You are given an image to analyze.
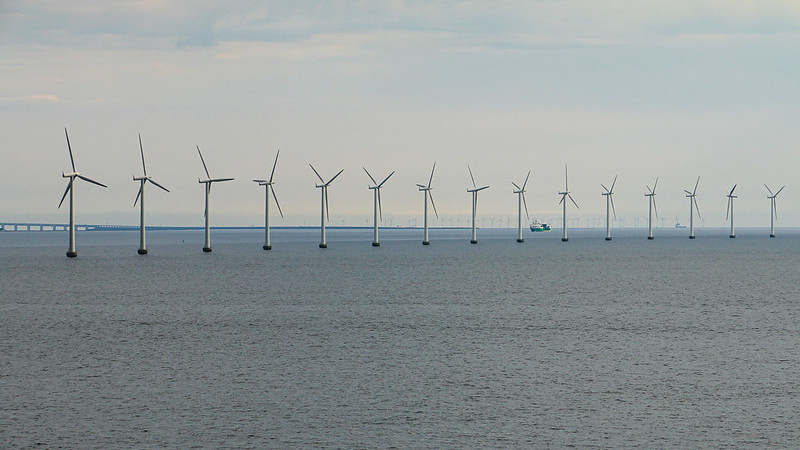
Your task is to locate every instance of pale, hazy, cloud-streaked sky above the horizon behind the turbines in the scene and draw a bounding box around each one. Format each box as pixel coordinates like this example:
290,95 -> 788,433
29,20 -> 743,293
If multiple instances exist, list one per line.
0,0 -> 800,227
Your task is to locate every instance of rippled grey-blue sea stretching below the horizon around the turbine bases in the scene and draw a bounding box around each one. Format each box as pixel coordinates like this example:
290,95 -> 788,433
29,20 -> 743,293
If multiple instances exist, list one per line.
0,228 -> 800,448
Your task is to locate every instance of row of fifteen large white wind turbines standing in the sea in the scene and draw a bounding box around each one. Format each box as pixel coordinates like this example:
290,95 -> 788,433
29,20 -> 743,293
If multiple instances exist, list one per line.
58,128 -> 786,258
